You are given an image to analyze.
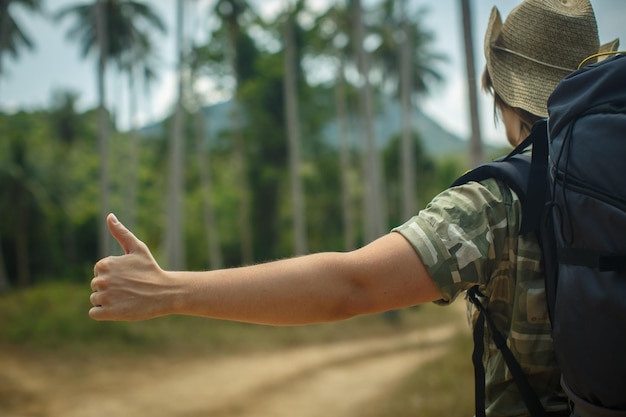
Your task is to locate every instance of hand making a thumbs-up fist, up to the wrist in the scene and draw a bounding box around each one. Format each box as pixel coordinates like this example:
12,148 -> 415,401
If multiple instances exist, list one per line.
89,214 -> 174,321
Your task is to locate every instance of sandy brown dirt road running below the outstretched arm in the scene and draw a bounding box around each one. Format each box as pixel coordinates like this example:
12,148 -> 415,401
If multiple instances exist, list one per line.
0,312 -> 461,417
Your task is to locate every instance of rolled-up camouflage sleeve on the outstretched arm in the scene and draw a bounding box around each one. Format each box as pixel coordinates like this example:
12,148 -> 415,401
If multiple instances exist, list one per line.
393,179 -> 521,304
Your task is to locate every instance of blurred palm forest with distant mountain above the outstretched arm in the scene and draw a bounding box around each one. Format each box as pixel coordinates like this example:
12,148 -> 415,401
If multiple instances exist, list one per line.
0,0 -> 510,290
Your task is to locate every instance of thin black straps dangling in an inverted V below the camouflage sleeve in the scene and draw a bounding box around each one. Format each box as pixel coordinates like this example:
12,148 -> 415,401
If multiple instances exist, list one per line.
467,285 -> 546,417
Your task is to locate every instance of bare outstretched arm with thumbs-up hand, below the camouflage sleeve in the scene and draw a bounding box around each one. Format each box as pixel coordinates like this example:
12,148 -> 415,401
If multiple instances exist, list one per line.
89,215 -> 441,325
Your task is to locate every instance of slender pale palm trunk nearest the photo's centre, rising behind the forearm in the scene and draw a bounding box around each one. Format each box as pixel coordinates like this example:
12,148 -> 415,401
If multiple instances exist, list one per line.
283,10 -> 308,255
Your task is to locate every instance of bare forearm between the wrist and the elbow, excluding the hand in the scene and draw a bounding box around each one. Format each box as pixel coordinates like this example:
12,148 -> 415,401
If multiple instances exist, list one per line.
167,253 -> 374,325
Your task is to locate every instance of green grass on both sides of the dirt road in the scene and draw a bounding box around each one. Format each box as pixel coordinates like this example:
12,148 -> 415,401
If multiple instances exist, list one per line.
0,283 -> 474,417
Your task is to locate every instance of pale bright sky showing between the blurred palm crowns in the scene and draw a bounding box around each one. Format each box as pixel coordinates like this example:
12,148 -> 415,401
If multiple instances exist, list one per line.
0,0 -> 626,144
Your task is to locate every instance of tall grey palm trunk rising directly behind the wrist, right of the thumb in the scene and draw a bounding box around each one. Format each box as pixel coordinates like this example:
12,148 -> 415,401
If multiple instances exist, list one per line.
165,0 -> 185,270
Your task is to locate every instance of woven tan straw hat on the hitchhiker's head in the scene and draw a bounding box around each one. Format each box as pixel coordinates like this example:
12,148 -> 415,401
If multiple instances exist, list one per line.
485,0 -> 619,117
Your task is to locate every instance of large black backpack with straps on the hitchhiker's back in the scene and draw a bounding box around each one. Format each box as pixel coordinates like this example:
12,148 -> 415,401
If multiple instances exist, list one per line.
453,55 -> 626,417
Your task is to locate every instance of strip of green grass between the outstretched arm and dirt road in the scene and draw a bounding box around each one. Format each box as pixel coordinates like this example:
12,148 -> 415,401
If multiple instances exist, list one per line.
0,283 -> 458,354
